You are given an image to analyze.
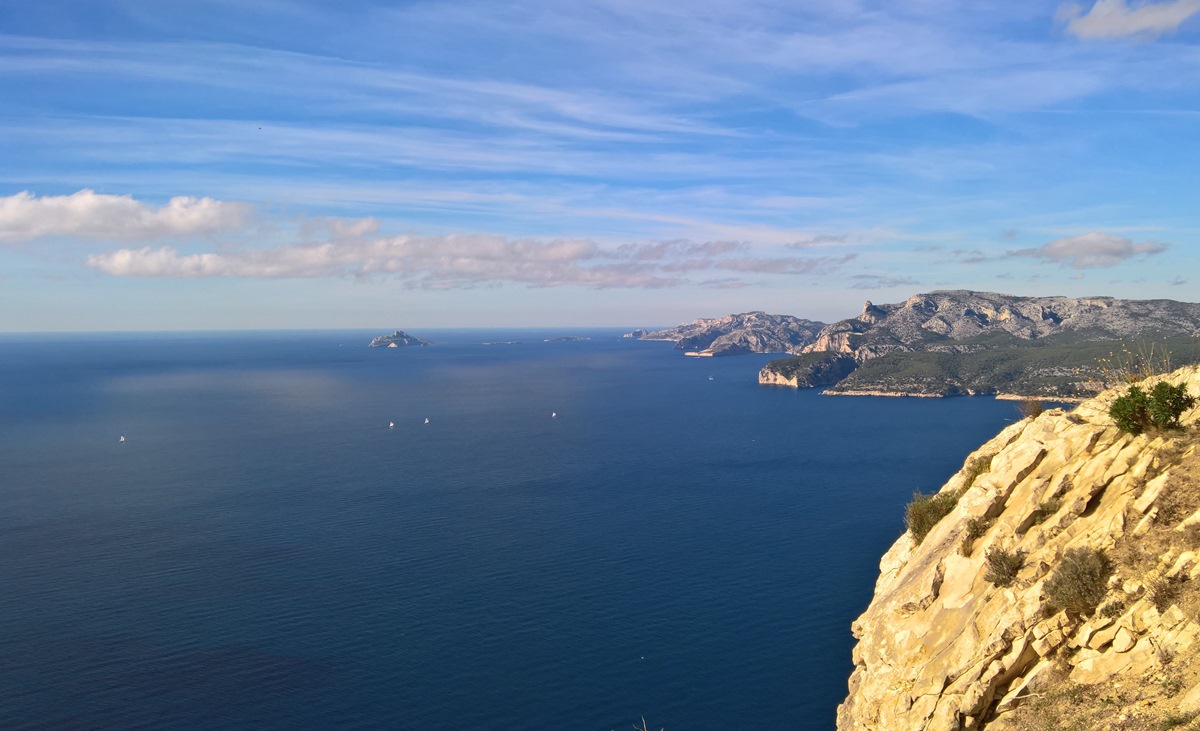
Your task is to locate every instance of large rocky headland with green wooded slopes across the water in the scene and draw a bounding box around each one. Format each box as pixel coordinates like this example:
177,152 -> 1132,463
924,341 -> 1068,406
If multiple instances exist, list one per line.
758,290 -> 1200,400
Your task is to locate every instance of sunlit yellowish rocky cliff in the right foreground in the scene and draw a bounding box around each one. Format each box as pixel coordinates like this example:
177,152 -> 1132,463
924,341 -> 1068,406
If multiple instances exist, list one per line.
838,367 -> 1200,731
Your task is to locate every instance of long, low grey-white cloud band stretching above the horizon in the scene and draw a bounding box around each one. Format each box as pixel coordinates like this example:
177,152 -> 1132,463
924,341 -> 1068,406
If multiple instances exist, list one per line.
86,234 -> 854,289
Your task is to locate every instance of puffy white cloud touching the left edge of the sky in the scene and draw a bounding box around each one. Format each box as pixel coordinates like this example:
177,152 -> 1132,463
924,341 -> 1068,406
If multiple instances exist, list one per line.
0,190 -> 251,242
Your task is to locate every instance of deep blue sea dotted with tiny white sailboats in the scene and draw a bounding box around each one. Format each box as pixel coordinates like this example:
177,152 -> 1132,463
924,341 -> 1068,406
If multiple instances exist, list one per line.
0,330 -> 1016,731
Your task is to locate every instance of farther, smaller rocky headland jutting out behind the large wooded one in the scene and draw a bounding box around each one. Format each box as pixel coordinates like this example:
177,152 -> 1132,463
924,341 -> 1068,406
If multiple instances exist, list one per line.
641,312 -> 824,355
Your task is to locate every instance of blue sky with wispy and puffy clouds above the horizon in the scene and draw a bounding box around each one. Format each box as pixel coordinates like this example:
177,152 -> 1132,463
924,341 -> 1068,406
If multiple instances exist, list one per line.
0,0 -> 1200,332
